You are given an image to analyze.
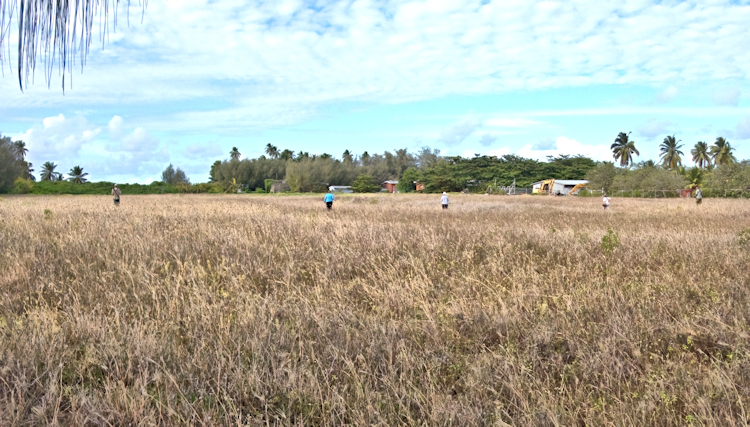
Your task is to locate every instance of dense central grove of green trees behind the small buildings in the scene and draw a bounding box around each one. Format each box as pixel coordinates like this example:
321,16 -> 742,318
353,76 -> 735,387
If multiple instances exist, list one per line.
210,144 -> 596,192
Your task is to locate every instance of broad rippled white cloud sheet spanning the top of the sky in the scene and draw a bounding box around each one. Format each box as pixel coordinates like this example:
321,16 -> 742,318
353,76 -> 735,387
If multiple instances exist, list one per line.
0,0 -> 750,130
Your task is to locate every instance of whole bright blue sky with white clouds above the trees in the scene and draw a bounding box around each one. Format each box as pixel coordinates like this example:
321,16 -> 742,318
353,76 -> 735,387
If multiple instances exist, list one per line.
0,0 -> 750,183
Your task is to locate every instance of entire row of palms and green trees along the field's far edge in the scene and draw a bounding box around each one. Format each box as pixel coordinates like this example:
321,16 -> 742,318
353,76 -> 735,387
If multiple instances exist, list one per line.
0,132 -> 750,196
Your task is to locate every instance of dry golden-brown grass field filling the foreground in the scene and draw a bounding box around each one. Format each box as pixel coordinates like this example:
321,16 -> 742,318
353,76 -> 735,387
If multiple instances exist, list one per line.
0,195 -> 750,426
